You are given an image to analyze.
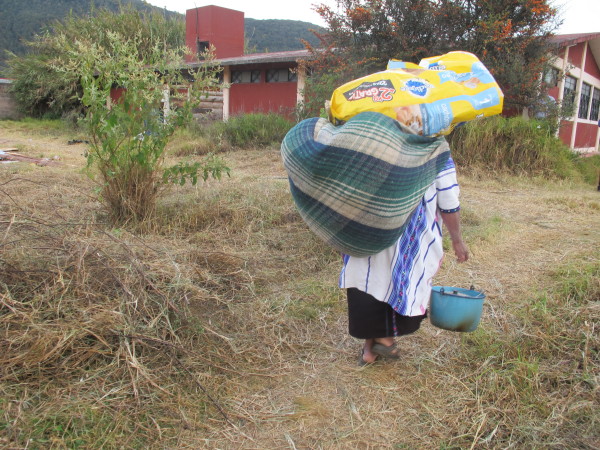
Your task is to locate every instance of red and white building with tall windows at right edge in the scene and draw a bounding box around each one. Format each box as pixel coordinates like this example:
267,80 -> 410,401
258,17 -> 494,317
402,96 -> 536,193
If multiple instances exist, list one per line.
545,33 -> 600,152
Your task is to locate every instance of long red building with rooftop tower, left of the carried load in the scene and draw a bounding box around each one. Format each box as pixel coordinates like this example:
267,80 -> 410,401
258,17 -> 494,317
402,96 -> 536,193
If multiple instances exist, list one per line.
186,6 -> 310,120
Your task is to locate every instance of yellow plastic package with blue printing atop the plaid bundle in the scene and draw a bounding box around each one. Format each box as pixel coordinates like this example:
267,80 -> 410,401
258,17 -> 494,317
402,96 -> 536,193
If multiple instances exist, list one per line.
330,52 -> 504,136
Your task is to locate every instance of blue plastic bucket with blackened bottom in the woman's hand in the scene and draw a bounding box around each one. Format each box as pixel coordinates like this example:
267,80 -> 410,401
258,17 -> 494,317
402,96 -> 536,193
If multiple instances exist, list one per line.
429,286 -> 485,332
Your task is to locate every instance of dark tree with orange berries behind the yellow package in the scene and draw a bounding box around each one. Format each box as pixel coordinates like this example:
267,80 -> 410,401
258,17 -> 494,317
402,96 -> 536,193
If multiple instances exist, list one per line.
310,0 -> 558,112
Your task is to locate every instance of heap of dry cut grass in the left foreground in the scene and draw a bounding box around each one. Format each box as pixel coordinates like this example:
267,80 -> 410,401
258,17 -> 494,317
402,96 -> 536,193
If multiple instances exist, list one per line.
0,169 -> 260,448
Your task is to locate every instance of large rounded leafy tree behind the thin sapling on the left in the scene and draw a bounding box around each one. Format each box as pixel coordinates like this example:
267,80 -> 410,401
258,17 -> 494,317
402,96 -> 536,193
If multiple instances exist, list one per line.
8,6 -> 185,117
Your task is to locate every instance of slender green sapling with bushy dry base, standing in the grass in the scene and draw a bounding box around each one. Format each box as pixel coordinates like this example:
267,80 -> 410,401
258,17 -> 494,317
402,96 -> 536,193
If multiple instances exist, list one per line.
54,31 -> 229,224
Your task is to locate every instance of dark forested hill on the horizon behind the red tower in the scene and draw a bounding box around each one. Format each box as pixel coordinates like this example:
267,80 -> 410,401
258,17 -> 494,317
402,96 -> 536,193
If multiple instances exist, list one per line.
0,0 -> 322,75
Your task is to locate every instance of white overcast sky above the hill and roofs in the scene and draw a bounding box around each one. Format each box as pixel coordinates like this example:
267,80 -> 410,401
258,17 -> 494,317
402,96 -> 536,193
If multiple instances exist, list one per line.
146,0 -> 600,34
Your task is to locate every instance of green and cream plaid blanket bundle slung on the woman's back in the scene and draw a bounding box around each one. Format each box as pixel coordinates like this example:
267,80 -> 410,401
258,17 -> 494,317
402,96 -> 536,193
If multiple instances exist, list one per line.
281,112 -> 450,256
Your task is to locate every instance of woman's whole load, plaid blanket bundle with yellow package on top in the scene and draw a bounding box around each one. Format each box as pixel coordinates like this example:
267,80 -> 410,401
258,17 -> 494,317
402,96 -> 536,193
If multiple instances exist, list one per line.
281,52 -> 503,256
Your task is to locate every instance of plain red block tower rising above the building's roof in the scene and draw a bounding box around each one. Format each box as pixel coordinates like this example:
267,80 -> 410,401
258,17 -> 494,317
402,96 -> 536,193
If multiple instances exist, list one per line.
185,5 -> 244,62
